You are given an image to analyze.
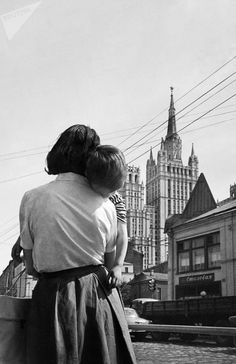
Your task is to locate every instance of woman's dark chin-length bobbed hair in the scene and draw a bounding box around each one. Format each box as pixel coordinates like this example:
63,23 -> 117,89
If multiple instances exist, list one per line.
46,124 -> 100,176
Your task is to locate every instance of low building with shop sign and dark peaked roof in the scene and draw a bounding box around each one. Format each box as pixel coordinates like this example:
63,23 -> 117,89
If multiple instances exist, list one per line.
165,174 -> 236,299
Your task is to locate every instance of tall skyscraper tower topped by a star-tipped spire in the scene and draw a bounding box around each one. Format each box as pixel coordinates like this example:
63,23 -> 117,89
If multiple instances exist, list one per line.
146,87 -> 198,264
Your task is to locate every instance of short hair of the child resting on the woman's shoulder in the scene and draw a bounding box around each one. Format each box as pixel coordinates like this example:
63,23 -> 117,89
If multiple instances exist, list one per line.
86,145 -> 126,191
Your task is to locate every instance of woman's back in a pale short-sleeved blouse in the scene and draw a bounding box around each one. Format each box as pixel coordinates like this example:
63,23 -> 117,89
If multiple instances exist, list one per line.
21,173 -> 117,272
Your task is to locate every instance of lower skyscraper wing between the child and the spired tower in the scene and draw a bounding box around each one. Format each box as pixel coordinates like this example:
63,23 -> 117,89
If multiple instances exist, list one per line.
119,166 -> 156,269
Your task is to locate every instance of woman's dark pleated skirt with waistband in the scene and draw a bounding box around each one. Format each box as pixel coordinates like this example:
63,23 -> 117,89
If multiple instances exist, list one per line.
27,266 -> 136,364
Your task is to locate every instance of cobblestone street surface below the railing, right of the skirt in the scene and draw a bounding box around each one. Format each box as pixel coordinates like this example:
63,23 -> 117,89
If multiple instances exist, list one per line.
133,340 -> 236,364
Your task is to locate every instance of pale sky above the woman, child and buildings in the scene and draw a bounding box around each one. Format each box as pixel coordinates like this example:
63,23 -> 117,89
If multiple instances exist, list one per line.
0,0 -> 236,272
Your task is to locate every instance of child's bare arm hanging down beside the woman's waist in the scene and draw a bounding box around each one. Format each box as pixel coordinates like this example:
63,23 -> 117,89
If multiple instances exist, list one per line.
105,220 -> 128,288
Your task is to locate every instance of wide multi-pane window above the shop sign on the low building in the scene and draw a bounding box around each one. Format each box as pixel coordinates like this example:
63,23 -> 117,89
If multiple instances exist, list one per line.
177,232 -> 220,273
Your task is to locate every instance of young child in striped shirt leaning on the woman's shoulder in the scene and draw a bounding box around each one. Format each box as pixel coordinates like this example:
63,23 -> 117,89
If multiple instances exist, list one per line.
86,145 -> 128,288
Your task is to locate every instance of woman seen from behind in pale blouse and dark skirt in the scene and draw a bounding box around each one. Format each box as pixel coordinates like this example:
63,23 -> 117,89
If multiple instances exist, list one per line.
20,125 -> 136,364
